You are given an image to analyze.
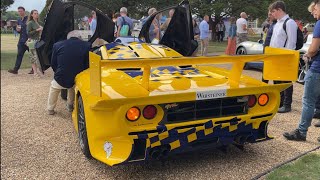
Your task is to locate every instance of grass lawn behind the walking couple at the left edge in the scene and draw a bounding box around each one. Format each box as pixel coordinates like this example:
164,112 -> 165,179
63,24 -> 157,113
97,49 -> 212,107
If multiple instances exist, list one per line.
1,34 -> 31,70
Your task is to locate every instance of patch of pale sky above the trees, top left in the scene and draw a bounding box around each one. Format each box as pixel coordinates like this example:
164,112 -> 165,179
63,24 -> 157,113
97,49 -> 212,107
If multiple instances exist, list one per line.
7,0 -> 46,12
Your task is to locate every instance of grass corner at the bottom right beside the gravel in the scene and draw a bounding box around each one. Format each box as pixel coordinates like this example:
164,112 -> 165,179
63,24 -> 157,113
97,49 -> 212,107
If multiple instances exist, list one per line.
266,153 -> 320,180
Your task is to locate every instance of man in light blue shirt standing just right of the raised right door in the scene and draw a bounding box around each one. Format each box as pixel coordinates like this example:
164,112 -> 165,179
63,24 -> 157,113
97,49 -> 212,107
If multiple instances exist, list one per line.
199,15 -> 212,56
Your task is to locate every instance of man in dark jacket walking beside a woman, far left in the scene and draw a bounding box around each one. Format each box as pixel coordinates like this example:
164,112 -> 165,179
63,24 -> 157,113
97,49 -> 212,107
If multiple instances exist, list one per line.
8,6 -> 31,74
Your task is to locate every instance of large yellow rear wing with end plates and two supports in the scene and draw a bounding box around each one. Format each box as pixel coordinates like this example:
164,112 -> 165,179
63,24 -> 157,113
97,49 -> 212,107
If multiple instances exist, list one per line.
89,47 -> 299,97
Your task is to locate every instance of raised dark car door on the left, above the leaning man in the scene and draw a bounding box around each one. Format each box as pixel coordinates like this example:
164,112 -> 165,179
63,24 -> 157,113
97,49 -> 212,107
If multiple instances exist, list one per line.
36,0 -> 115,70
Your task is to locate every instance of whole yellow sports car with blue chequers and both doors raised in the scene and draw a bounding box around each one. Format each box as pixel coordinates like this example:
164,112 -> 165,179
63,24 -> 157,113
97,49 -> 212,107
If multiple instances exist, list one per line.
37,0 -> 299,166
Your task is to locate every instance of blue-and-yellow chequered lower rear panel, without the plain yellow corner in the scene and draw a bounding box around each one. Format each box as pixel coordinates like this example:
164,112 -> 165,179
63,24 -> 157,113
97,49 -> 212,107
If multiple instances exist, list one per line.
127,118 -> 271,162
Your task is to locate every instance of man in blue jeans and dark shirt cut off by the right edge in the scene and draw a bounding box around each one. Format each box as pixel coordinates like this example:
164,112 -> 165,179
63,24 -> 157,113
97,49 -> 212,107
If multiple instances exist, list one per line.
283,0 -> 320,142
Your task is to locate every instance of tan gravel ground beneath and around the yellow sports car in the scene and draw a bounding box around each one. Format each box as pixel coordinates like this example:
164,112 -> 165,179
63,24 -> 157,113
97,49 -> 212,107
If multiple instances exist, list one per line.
1,69 -> 320,180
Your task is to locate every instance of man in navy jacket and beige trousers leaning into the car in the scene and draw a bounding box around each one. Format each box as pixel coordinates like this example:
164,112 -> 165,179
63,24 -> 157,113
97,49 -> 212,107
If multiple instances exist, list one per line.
47,31 -> 91,115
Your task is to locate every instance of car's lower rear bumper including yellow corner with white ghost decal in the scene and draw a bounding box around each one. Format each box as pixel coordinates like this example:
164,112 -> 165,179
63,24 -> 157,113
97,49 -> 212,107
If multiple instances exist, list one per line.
90,113 -> 274,166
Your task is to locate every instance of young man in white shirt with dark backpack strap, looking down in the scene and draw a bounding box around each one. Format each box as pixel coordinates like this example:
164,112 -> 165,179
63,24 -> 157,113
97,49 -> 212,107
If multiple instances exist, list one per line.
269,1 -> 298,113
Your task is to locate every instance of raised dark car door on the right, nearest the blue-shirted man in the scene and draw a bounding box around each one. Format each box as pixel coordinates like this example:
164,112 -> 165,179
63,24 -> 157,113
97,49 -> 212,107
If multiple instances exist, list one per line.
139,1 -> 198,56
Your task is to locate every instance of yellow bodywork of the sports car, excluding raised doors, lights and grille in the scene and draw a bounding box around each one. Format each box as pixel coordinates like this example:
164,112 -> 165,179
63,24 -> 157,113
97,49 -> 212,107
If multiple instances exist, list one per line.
72,43 -> 299,166
